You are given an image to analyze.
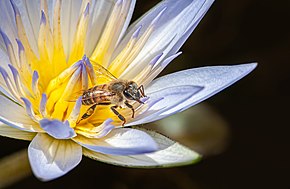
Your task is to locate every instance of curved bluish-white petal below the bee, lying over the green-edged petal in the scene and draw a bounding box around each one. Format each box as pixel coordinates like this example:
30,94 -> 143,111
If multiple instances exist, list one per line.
73,128 -> 157,155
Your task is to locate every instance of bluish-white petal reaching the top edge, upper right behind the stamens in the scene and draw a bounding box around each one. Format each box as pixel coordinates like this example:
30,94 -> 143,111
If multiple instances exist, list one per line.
114,0 -> 214,77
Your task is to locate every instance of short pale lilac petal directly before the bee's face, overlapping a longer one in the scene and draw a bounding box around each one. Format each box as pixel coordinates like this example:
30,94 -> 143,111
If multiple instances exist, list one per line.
126,85 -> 203,126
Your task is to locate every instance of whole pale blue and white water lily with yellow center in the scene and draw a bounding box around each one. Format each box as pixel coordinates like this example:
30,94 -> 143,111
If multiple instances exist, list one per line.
0,0 -> 256,181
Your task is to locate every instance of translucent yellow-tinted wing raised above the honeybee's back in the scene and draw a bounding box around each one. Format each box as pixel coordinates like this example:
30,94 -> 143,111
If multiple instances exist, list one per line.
93,63 -> 117,84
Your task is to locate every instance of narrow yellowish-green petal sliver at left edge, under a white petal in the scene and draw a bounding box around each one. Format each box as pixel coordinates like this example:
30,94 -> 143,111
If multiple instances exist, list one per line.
0,123 -> 36,141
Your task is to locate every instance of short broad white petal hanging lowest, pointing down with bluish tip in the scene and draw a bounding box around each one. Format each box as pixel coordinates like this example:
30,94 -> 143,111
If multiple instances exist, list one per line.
28,133 -> 82,181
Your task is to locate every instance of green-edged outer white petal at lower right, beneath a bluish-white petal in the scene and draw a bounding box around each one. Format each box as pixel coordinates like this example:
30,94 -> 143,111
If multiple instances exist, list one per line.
83,128 -> 201,168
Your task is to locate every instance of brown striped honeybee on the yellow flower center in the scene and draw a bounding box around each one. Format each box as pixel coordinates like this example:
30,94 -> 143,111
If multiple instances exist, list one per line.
79,63 -> 146,126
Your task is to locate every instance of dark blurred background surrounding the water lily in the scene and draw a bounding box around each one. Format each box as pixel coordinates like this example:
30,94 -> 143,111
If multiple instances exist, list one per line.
0,0 -> 290,189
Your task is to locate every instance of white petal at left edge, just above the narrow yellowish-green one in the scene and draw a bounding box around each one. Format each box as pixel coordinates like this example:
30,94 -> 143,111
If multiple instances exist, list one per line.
0,95 -> 43,132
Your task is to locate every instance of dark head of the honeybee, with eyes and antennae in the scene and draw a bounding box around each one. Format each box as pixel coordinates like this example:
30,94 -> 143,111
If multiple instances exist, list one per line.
123,81 -> 144,103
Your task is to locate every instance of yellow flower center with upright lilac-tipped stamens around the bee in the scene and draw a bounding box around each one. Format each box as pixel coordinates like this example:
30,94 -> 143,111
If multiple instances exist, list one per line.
2,1 -> 152,137
